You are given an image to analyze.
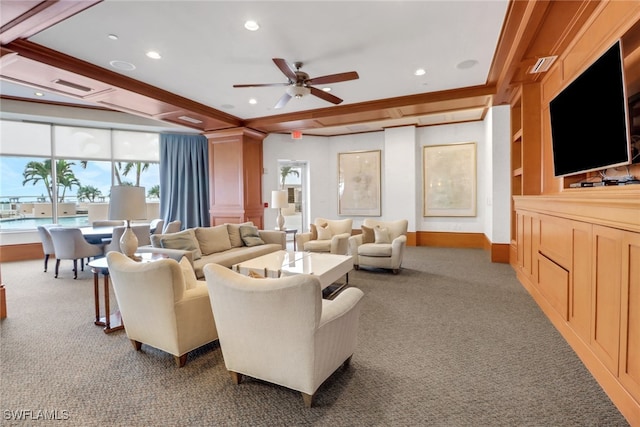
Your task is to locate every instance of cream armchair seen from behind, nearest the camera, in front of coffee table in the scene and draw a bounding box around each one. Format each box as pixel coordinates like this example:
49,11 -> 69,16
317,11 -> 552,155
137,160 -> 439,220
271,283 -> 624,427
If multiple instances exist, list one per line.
204,264 -> 363,407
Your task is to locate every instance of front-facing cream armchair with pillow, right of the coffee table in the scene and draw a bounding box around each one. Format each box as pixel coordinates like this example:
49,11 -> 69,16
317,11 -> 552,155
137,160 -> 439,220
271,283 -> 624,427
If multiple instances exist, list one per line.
349,219 -> 408,274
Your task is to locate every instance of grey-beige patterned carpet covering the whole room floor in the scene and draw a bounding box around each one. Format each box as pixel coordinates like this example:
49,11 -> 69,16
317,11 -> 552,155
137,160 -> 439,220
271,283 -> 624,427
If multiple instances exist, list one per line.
0,247 -> 628,426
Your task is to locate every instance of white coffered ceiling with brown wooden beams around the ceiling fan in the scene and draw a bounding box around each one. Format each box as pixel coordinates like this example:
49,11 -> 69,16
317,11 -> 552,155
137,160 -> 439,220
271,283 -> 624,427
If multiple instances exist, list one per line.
0,0 -> 597,135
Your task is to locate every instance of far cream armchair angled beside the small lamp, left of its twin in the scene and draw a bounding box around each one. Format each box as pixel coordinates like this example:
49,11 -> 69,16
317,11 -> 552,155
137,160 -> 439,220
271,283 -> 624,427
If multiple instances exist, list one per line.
296,218 -> 353,255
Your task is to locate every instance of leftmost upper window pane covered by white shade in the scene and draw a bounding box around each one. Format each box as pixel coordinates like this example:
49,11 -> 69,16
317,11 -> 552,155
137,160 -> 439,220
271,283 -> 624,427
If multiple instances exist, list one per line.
0,120 -> 51,156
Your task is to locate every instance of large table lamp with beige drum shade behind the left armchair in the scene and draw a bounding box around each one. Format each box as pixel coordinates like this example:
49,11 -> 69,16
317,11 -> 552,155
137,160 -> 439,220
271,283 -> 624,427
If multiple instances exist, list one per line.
109,185 -> 147,258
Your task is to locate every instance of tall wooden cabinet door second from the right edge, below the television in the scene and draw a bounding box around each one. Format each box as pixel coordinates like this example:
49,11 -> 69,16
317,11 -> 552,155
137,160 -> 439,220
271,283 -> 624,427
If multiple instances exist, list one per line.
591,225 -> 624,376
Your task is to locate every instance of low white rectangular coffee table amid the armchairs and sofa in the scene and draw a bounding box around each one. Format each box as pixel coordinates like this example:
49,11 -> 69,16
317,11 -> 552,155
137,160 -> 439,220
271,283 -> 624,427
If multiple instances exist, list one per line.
232,251 -> 353,294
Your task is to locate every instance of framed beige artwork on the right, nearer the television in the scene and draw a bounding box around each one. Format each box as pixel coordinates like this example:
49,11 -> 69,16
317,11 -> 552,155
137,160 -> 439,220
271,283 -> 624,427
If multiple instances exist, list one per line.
422,142 -> 476,216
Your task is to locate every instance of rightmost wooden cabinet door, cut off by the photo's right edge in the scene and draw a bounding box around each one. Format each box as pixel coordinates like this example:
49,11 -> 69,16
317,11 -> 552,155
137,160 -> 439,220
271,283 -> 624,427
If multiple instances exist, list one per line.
620,232 -> 640,402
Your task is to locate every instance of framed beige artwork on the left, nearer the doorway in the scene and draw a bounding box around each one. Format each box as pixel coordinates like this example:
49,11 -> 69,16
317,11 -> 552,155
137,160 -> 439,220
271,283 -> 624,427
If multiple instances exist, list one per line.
338,150 -> 381,216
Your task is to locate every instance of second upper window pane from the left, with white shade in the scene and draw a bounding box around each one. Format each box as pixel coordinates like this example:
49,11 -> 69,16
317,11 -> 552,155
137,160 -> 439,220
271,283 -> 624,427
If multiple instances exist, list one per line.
53,126 -> 111,159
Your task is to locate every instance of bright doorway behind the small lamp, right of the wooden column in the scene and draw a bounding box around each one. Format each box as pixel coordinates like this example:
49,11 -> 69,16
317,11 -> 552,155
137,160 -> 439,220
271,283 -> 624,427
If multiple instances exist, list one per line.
278,160 -> 309,237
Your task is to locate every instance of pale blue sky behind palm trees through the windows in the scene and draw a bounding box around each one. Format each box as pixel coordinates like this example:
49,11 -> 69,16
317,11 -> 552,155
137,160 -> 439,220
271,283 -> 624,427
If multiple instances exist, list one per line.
0,156 -> 160,201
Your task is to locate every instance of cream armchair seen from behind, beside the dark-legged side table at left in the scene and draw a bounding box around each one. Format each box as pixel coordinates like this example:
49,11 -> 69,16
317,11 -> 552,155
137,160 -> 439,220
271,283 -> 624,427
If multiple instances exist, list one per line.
107,252 -> 218,367
